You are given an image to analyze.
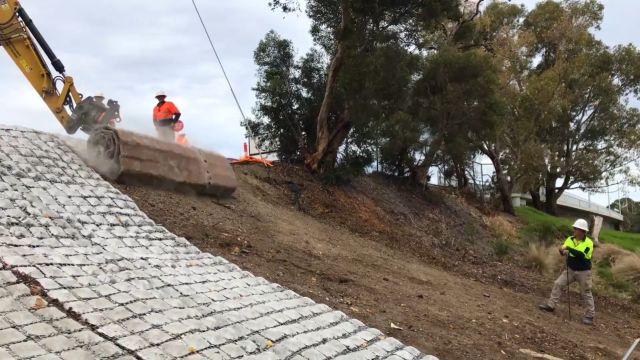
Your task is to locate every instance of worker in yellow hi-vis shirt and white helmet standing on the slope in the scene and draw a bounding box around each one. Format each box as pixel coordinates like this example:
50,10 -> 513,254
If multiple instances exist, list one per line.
539,219 -> 596,325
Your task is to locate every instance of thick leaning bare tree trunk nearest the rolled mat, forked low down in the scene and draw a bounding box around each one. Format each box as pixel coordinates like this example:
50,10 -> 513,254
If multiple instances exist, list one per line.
305,0 -> 351,173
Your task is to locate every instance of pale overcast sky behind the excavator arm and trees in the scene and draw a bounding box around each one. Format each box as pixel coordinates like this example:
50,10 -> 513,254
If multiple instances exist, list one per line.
0,0 -> 640,203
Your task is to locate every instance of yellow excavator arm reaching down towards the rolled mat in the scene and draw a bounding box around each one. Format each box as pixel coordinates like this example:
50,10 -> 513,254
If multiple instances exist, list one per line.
0,0 -> 120,134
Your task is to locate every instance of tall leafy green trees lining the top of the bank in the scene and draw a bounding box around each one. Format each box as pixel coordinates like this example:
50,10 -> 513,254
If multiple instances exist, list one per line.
258,0 -> 640,211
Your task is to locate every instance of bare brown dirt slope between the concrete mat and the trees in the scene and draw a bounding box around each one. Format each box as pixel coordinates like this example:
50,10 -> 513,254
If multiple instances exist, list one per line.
116,167 -> 640,359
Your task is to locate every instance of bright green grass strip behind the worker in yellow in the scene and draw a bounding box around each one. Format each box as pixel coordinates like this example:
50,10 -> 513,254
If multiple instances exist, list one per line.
516,206 -> 640,251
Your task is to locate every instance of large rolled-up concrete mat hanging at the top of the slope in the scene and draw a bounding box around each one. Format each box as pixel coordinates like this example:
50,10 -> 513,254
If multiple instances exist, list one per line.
86,127 -> 237,197
